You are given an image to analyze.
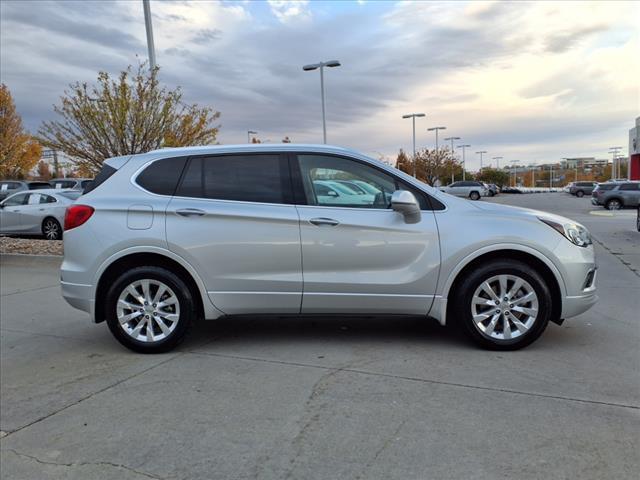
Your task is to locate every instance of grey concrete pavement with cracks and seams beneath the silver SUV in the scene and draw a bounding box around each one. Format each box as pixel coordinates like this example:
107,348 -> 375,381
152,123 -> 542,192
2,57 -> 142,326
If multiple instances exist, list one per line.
0,194 -> 640,480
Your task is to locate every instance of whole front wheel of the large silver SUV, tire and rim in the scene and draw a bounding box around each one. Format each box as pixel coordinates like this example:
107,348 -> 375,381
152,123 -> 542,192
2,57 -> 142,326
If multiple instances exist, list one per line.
451,260 -> 551,350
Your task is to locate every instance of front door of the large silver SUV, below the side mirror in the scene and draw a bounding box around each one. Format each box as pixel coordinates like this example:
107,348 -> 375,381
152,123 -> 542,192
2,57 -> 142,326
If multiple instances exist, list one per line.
297,154 -> 440,315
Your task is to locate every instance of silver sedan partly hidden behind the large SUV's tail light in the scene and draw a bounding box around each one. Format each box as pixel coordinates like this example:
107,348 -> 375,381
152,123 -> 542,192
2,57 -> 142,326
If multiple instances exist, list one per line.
0,188 -> 81,240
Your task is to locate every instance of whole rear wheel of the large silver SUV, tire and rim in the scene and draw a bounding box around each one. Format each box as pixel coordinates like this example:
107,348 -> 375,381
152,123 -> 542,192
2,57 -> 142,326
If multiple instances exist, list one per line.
106,266 -> 196,353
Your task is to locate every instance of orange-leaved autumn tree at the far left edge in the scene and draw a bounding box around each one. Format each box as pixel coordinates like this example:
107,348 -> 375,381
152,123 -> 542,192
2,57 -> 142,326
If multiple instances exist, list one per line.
0,84 -> 42,178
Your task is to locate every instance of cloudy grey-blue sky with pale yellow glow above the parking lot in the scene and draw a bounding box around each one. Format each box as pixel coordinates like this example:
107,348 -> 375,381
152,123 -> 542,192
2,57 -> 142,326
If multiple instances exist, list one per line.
0,0 -> 640,169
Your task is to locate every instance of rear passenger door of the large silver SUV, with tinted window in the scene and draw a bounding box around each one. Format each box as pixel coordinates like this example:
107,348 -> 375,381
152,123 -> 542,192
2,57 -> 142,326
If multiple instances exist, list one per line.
166,153 -> 302,314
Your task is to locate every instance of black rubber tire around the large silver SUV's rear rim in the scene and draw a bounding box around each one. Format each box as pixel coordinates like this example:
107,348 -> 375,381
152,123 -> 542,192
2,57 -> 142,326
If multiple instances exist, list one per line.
105,266 -> 197,353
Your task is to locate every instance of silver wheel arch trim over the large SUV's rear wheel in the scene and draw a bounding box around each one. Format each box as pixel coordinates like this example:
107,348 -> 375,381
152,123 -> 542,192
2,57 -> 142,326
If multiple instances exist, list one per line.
93,250 -> 222,323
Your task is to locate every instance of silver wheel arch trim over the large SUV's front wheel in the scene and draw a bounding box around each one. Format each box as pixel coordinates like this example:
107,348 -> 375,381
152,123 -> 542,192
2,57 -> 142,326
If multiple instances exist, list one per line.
432,245 -> 566,325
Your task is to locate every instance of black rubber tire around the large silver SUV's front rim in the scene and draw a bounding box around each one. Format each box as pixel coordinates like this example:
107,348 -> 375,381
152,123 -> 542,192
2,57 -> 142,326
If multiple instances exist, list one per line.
450,260 -> 552,350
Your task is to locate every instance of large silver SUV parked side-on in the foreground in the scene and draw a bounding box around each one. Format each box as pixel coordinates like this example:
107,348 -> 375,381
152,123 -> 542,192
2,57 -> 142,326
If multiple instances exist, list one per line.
61,144 -> 597,352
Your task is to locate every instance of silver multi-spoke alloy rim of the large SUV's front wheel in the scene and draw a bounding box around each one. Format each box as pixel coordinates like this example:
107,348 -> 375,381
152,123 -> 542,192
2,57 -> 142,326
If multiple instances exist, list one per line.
471,274 -> 538,341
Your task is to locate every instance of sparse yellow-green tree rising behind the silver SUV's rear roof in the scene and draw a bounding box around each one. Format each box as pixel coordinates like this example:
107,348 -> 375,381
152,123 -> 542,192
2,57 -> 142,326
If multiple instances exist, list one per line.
38,64 -> 220,173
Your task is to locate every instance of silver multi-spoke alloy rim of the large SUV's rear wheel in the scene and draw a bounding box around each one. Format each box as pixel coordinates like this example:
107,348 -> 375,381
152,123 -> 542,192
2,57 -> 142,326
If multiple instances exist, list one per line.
116,279 -> 180,343
